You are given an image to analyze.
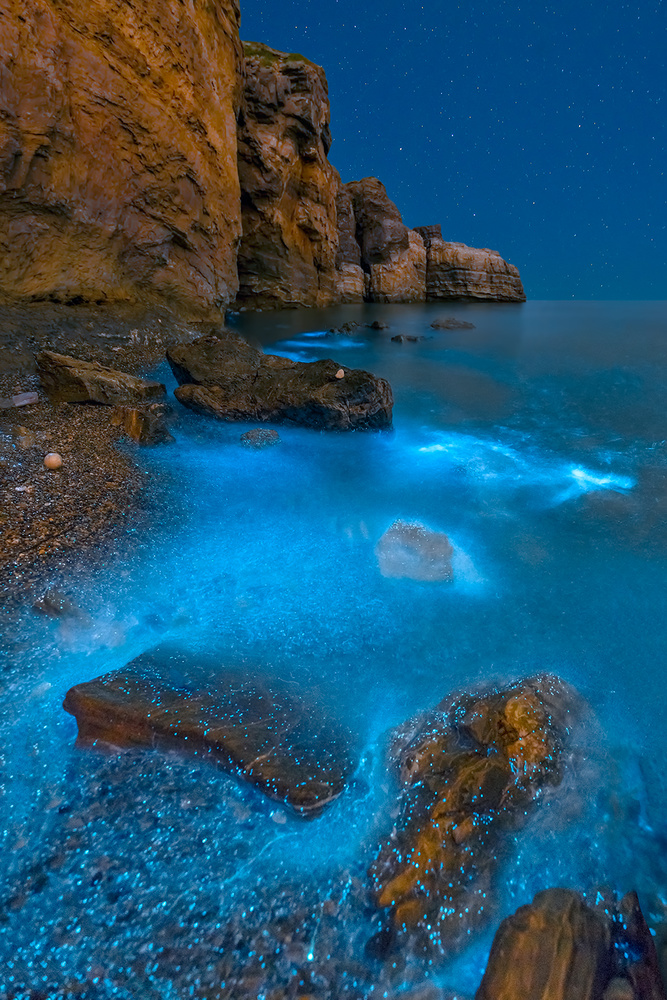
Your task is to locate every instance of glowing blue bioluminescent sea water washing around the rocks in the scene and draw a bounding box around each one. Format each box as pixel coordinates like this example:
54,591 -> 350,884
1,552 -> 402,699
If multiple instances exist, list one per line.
0,302 -> 667,1000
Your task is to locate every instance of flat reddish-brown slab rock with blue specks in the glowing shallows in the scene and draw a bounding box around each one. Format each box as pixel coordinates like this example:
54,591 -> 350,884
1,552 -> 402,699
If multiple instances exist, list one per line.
64,647 -> 356,815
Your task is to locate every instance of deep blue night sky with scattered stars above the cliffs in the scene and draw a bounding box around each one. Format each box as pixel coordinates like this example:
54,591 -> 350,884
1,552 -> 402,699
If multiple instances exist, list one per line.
241,0 -> 667,299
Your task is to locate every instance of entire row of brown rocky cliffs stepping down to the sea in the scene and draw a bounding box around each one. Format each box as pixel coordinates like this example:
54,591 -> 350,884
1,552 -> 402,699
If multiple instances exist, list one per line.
0,0 -> 524,311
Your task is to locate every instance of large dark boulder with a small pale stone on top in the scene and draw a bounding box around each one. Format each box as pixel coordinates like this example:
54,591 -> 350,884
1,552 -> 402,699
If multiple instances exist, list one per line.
167,334 -> 393,430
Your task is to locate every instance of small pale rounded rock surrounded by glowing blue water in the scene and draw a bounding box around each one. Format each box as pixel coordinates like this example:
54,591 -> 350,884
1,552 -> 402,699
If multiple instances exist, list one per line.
375,521 -> 454,583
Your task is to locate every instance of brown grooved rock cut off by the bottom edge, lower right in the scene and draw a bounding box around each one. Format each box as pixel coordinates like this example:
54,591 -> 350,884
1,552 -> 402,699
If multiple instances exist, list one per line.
476,889 -> 611,1000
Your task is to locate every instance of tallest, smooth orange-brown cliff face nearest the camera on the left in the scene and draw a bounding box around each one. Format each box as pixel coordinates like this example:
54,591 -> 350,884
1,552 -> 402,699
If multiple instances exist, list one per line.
0,0 -> 242,308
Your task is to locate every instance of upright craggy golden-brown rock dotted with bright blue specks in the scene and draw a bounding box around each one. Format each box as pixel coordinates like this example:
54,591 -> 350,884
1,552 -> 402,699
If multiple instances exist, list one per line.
370,675 -> 579,952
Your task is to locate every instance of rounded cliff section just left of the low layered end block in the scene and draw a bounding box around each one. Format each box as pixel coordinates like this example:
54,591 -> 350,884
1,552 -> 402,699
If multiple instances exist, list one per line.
346,177 -> 426,302
